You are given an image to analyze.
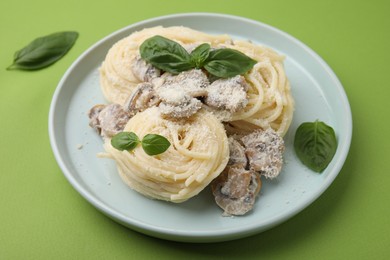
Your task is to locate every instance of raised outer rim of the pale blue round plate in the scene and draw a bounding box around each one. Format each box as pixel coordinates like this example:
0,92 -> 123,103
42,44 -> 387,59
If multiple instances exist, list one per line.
48,12 -> 352,242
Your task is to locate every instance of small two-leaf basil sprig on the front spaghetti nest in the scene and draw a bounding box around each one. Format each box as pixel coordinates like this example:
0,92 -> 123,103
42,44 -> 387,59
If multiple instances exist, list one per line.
111,132 -> 171,155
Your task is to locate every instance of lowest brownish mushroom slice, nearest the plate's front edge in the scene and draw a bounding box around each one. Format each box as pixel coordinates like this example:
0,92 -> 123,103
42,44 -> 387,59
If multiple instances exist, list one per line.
211,166 -> 261,216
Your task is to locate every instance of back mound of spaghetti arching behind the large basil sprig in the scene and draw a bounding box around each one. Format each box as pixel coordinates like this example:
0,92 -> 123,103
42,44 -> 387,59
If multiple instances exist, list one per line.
100,26 -> 294,136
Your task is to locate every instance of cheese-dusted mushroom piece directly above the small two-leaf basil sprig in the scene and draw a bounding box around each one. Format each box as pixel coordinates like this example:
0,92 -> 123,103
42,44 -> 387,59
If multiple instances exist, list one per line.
97,104 -> 131,137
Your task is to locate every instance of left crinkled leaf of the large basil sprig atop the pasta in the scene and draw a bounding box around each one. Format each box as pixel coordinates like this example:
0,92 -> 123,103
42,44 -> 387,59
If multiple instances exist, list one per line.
140,35 -> 193,74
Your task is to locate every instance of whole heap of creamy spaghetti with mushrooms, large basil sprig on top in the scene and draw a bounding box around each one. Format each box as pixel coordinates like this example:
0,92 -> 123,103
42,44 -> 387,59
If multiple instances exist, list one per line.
89,26 -> 294,215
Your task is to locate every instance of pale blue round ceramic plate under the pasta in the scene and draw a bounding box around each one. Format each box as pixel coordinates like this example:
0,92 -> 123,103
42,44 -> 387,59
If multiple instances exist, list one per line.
49,13 -> 352,242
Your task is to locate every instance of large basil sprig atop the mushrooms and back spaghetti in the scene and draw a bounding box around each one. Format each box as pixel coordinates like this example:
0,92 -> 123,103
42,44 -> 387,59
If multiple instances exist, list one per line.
140,35 -> 257,78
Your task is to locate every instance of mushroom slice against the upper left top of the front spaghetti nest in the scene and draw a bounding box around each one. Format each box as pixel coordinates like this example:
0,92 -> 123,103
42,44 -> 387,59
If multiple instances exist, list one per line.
123,82 -> 160,115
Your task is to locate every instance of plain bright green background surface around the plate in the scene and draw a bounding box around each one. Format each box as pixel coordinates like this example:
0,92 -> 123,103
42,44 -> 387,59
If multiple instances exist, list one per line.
0,0 -> 390,259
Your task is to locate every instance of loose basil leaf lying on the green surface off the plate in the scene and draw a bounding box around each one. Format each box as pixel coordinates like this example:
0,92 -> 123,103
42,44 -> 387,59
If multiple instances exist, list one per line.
7,32 -> 78,70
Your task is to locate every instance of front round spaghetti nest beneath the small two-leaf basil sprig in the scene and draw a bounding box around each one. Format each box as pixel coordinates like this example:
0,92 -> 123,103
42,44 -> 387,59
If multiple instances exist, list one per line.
104,107 -> 229,202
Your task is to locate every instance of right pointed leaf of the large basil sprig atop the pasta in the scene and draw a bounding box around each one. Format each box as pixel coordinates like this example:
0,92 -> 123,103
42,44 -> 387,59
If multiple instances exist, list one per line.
204,48 -> 257,78
